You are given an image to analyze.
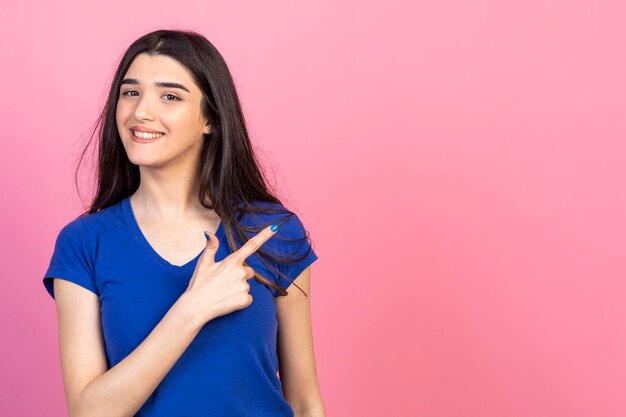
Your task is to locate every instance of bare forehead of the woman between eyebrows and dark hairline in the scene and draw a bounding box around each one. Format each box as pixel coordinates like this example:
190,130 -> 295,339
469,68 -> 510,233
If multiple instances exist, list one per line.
124,54 -> 199,92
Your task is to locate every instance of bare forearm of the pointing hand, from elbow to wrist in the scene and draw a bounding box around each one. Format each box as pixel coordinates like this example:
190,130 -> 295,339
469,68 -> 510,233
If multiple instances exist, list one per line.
70,294 -> 202,417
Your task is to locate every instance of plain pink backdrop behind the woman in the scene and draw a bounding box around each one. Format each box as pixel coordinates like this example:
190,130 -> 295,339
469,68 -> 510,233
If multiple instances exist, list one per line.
0,0 -> 626,417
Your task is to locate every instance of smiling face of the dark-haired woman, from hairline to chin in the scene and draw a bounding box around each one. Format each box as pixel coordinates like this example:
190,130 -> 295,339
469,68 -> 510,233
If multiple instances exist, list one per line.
115,54 -> 210,168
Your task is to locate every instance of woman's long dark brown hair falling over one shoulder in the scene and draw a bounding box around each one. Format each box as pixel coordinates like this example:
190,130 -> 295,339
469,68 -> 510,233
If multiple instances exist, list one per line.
75,30 -> 311,296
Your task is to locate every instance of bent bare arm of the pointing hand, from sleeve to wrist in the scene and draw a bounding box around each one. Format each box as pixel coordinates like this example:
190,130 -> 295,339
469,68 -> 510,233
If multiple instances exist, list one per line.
54,279 -> 202,417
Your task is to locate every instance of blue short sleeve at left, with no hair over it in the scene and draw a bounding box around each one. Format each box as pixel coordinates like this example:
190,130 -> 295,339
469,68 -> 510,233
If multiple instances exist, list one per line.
43,218 -> 100,298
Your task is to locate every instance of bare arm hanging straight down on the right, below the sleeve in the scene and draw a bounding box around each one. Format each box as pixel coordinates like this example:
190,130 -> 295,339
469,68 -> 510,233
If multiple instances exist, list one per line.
276,267 -> 326,417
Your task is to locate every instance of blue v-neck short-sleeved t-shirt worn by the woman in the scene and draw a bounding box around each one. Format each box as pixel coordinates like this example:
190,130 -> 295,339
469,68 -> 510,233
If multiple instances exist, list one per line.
43,197 -> 317,417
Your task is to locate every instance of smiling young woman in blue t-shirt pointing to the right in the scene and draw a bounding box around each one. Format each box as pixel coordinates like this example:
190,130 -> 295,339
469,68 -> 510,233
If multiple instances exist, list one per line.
43,30 -> 324,417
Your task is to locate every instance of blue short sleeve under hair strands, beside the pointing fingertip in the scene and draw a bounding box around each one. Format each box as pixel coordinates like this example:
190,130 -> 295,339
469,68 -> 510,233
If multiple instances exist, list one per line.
274,214 -> 318,290
